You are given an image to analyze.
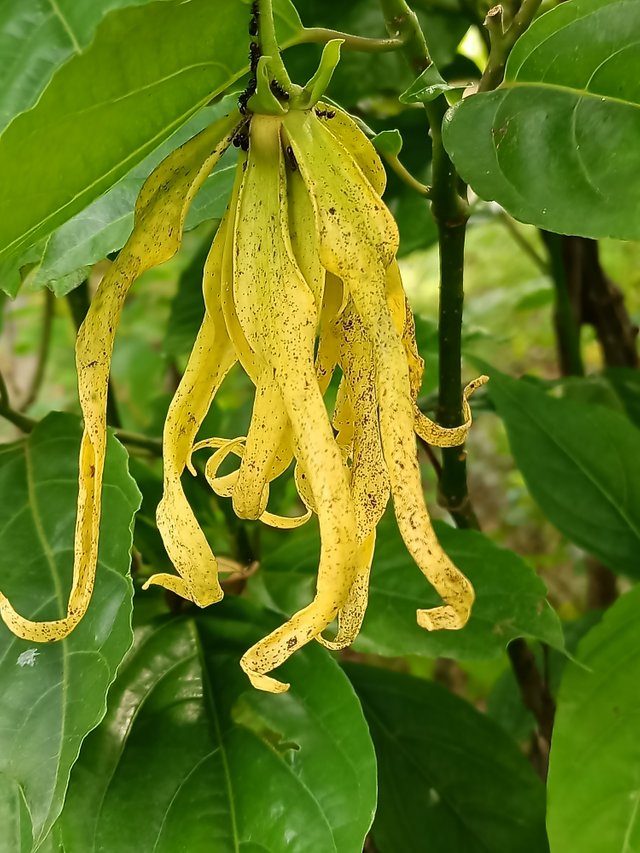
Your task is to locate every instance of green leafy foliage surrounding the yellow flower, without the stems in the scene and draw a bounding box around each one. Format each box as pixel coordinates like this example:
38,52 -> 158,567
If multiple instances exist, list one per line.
0,0 -> 640,853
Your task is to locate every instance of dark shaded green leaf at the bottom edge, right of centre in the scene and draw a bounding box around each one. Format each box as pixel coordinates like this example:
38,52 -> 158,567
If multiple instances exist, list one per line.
345,664 -> 552,853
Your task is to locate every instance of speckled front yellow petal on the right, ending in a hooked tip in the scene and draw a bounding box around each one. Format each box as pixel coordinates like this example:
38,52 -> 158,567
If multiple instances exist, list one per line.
284,112 -> 474,630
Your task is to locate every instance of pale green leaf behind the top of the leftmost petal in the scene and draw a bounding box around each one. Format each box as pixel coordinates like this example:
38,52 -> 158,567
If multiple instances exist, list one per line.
27,103 -> 237,296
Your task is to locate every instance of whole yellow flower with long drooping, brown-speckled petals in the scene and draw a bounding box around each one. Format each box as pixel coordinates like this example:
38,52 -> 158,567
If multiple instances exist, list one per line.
0,71 -> 485,692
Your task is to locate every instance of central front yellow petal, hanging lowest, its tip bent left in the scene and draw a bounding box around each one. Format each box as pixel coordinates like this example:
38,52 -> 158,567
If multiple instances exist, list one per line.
234,115 -> 356,692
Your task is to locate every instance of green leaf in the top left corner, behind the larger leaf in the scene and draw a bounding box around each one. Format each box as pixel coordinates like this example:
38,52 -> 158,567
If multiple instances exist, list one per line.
0,0 -> 175,131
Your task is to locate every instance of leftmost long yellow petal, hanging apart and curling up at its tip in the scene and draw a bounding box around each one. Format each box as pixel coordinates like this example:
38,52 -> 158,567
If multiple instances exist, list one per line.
0,113 -> 240,642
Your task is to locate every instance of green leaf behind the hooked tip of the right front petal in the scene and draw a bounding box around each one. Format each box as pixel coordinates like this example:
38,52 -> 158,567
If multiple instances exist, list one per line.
252,517 -> 563,660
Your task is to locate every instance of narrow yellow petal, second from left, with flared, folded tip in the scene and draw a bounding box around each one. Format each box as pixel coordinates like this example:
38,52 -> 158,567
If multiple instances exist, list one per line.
148,213 -> 236,607
